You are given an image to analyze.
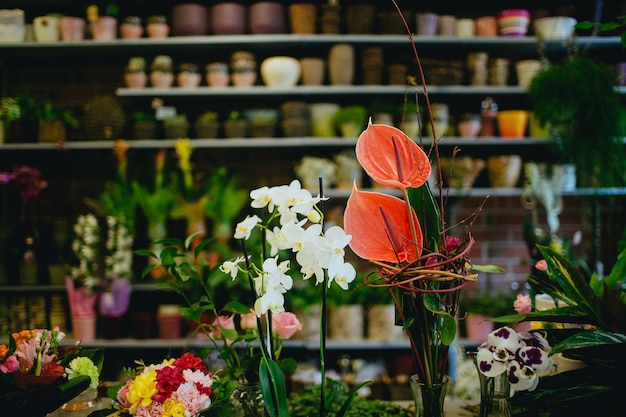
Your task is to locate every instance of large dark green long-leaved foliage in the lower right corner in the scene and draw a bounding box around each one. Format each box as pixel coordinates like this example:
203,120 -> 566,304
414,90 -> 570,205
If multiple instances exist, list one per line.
494,245 -> 626,416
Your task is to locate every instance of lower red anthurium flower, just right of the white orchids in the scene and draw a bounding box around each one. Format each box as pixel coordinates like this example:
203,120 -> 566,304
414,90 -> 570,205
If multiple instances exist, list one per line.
344,186 -> 423,263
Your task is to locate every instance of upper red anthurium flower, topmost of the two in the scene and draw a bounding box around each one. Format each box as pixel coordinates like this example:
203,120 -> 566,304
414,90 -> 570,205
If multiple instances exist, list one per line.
356,119 -> 431,189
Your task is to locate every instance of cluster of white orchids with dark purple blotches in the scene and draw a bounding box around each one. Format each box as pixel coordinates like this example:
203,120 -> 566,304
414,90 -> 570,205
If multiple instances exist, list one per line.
476,326 -> 552,391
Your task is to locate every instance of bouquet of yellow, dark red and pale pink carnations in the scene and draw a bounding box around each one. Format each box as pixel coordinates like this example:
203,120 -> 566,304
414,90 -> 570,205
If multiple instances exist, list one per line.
115,353 -> 216,417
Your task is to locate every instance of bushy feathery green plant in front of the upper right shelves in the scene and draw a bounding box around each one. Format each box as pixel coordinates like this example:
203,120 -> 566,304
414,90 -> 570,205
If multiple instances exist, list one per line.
528,56 -> 626,187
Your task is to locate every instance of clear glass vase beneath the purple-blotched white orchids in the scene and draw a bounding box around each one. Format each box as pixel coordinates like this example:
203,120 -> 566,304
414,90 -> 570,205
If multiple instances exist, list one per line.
474,357 -> 511,417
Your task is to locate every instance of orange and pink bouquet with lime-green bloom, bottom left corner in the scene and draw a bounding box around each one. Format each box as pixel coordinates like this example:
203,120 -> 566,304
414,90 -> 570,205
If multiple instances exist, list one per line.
0,328 -> 104,417
